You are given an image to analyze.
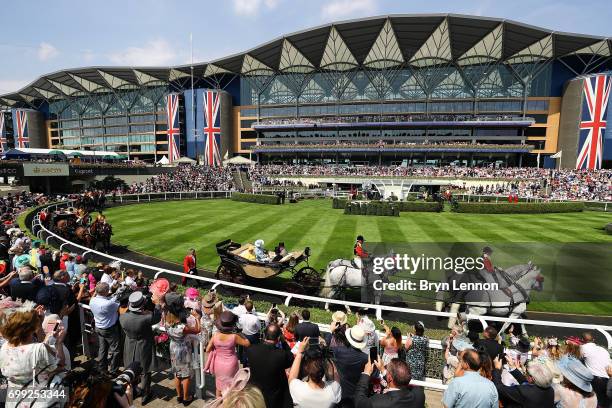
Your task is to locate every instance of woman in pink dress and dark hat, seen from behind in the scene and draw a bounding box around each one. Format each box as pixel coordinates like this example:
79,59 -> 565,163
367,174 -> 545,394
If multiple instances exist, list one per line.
205,310 -> 251,398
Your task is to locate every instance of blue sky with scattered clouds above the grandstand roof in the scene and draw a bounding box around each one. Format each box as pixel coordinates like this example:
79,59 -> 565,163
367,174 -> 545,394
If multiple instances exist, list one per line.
0,0 -> 612,94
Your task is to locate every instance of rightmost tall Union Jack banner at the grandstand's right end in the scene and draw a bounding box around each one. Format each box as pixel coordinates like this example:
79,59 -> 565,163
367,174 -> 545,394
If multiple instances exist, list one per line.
576,74 -> 612,169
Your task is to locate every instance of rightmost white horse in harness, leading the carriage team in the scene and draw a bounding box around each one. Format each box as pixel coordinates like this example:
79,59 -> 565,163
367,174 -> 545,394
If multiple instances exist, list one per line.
464,263 -> 544,334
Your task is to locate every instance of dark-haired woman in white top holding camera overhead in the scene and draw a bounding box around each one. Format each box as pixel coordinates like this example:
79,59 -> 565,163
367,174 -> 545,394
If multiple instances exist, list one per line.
288,337 -> 342,408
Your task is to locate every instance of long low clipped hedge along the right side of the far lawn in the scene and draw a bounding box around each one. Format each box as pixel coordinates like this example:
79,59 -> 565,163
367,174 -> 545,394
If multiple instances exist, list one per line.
453,202 -> 584,214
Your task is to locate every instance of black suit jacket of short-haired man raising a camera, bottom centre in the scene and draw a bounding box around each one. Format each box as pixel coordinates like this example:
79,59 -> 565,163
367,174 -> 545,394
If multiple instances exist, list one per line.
355,374 -> 425,408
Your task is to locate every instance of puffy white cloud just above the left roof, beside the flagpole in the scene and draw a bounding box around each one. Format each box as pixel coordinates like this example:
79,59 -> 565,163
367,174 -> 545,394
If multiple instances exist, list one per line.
108,39 -> 180,66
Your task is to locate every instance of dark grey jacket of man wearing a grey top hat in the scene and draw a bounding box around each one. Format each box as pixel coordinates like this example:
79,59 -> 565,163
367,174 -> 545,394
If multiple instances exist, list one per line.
119,309 -> 161,373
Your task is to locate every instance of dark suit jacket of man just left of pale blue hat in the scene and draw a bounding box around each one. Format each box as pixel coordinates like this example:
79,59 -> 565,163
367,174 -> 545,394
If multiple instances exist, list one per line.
493,370 -> 555,408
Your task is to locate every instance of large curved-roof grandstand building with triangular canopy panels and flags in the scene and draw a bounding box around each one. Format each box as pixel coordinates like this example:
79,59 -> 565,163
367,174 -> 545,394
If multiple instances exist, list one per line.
0,14 -> 612,168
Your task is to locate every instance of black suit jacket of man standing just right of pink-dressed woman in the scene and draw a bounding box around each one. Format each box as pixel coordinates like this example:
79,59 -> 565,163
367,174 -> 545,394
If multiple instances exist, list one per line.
246,343 -> 293,408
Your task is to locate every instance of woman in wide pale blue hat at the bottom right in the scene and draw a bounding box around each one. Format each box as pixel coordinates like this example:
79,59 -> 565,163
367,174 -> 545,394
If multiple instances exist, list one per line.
555,356 -> 597,408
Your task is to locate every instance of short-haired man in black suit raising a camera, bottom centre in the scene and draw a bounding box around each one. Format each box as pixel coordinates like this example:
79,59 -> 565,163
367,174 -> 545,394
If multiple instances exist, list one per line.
355,358 -> 425,408
